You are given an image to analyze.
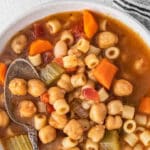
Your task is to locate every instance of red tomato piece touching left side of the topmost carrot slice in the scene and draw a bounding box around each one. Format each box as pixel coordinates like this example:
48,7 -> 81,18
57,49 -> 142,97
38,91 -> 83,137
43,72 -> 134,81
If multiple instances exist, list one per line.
71,21 -> 85,40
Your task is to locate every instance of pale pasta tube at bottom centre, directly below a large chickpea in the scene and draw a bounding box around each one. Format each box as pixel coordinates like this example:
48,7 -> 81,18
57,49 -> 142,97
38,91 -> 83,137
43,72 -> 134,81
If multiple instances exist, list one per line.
62,137 -> 78,149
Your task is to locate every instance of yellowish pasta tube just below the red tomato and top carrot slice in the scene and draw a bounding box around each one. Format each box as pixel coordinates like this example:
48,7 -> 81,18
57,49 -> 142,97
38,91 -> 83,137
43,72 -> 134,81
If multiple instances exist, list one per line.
76,38 -> 90,53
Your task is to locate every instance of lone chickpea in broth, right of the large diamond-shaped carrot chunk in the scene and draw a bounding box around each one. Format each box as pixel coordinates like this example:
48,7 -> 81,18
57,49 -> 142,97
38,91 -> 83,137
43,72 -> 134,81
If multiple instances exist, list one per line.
113,79 -> 133,96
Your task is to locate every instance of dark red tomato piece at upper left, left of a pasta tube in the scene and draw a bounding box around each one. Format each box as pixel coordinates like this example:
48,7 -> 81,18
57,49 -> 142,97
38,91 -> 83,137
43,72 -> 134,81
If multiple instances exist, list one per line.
33,23 -> 44,38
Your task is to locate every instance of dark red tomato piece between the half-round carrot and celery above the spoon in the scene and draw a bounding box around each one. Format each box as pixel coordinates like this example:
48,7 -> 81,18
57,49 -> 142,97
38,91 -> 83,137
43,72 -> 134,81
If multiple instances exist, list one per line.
42,51 -> 54,64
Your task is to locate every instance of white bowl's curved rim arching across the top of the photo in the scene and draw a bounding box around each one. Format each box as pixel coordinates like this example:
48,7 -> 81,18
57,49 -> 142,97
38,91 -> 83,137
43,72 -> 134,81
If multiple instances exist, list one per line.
0,0 -> 150,150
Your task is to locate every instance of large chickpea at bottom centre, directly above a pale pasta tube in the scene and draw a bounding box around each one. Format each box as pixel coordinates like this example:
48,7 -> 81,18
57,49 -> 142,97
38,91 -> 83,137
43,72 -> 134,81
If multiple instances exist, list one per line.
64,119 -> 83,140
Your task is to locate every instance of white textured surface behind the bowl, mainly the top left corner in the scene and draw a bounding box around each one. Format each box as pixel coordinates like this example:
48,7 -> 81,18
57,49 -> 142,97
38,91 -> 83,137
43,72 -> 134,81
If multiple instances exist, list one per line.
0,0 -> 111,33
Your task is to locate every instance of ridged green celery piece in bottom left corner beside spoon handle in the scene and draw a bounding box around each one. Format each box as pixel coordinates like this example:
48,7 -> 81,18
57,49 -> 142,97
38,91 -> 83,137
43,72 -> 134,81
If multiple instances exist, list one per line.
2,135 -> 32,150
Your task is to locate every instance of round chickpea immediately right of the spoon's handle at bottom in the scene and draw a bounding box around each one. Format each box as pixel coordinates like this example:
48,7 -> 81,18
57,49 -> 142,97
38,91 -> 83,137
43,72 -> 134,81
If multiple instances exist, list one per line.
39,125 -> 56,144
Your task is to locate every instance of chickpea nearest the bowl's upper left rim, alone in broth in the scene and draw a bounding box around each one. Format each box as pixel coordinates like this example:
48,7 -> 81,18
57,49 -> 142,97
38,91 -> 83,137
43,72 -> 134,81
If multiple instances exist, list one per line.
11,34 -> 27,54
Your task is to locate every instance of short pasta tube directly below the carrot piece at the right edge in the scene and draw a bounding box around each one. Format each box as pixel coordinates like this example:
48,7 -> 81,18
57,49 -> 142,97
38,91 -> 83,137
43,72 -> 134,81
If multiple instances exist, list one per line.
134,114 -> 147,126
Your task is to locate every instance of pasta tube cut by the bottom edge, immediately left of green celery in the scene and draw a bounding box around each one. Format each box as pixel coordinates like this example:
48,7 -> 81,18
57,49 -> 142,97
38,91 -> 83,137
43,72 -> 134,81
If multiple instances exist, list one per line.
85,139 -> 98,150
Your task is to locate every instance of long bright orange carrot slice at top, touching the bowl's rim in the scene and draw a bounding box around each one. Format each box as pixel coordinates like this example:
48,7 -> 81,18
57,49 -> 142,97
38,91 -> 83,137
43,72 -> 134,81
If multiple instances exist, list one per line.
83,10 -> 98,39
